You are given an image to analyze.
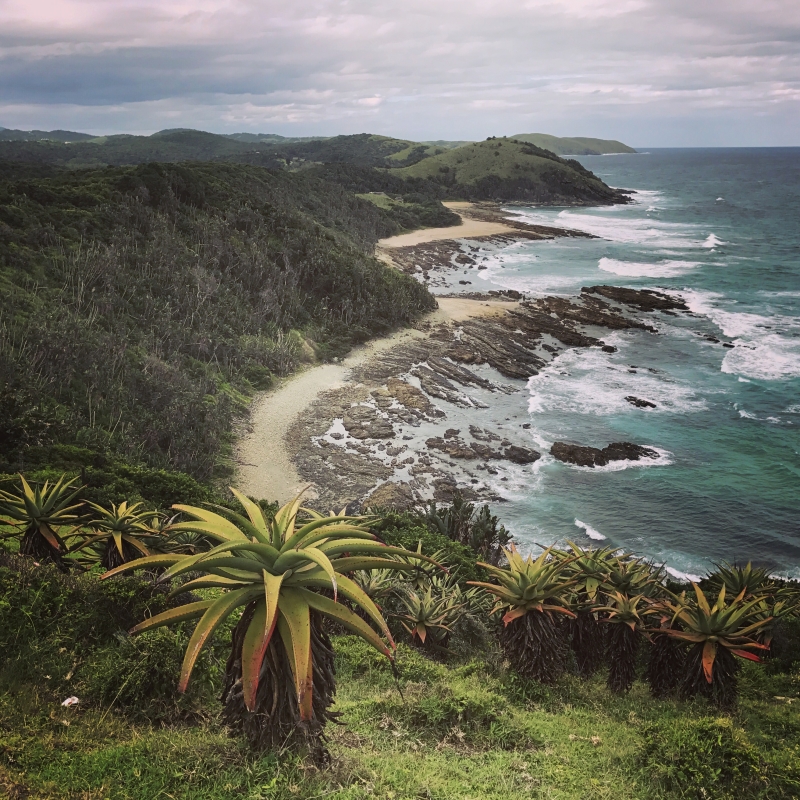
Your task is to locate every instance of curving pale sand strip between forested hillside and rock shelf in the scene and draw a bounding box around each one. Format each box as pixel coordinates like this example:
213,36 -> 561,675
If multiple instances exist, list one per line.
235,297 -> 514,503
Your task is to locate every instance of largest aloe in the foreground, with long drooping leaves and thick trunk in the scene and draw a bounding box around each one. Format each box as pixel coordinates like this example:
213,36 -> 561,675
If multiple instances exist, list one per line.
103,490 -> 432,757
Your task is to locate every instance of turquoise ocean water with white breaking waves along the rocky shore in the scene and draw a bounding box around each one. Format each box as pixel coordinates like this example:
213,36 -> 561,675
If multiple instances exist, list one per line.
454,148 -> 800,577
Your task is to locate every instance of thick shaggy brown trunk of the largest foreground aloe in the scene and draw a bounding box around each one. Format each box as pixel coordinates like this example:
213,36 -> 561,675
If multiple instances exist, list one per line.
221,603 -> 339,764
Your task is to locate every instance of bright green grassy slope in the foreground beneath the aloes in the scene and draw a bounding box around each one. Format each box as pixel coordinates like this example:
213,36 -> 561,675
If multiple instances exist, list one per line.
0,637 -> 800,800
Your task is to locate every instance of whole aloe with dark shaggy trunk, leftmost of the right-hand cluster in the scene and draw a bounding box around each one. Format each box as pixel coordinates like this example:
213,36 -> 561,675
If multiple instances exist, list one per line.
468,544 -> 575,683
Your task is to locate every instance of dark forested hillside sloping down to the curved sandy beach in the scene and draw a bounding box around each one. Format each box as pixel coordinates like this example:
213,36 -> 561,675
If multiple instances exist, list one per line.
0,163 -> 435,488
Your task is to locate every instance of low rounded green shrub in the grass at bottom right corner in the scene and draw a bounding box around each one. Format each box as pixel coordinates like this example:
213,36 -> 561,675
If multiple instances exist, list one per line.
637,716 -> 768,800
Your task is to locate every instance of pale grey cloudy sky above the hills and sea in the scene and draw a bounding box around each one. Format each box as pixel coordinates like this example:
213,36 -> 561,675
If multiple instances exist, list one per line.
0,0 -> 800,146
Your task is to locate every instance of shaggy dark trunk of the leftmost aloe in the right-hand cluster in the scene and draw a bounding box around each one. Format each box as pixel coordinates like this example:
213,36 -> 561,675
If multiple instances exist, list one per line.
500,611 -> 567,683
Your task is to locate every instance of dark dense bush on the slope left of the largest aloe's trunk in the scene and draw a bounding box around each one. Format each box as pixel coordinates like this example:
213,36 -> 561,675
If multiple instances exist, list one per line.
0,555 -> 223,720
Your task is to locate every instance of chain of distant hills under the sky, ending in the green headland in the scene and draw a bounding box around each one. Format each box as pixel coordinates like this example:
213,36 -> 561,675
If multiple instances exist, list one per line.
0,128 -> 624,203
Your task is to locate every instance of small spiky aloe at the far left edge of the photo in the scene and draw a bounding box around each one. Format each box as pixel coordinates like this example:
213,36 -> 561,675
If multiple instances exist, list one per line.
0,475 -> 83,571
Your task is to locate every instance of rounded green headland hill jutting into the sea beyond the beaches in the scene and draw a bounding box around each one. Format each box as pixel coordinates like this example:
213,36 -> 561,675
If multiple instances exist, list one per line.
393,138 -> 626,204
